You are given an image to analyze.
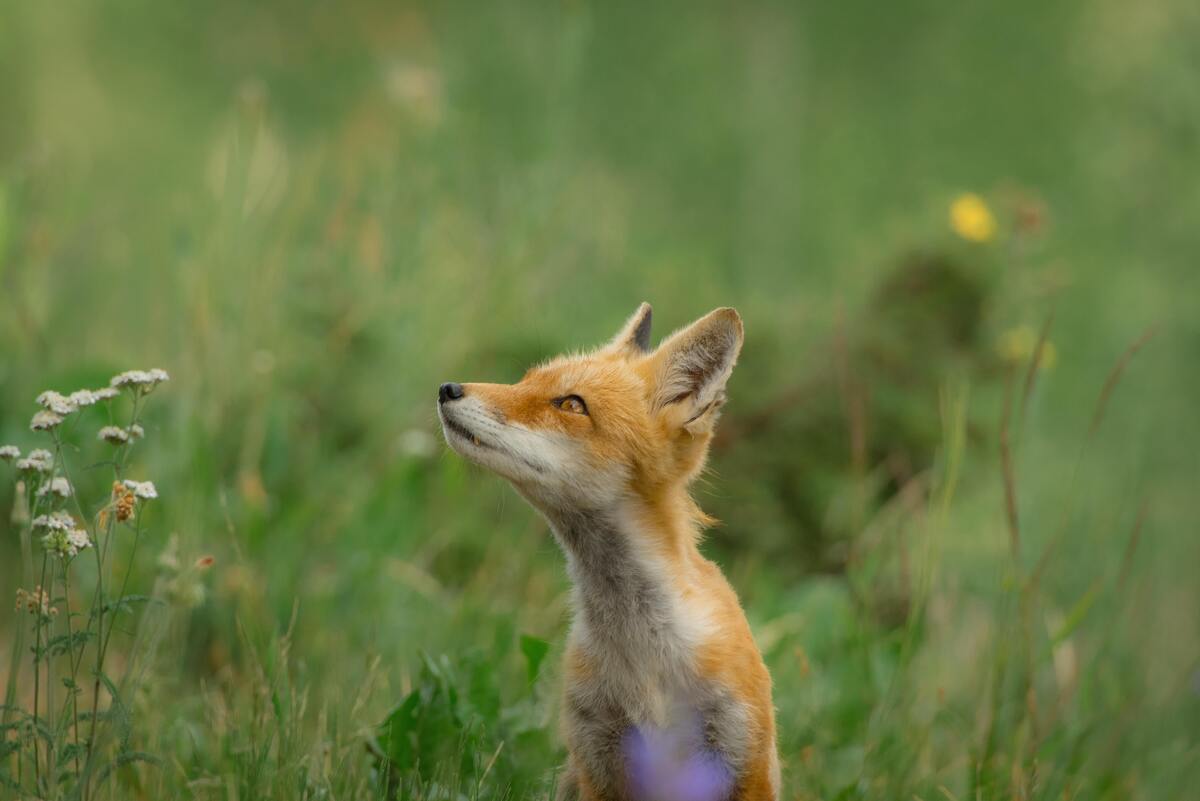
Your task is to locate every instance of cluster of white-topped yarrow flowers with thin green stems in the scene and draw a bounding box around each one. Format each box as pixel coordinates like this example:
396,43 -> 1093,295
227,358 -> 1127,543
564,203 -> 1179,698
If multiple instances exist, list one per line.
0,368 -> 169,799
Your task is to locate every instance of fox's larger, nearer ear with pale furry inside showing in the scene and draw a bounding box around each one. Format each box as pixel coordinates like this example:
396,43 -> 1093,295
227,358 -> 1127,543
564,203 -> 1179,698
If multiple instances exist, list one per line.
654,308 -> 743,429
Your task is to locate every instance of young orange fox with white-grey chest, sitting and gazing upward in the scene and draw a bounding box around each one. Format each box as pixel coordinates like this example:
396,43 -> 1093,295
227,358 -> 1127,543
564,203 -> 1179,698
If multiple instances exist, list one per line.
438,303 -> 779,801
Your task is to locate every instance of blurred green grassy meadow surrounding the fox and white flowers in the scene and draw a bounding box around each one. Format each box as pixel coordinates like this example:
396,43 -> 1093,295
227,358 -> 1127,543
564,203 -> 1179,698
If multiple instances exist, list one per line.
0,0 -> 1200,801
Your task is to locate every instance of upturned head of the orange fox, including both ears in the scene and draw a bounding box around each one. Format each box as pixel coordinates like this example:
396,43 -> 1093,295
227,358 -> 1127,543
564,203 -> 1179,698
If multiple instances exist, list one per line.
438,303 -> 743,518
